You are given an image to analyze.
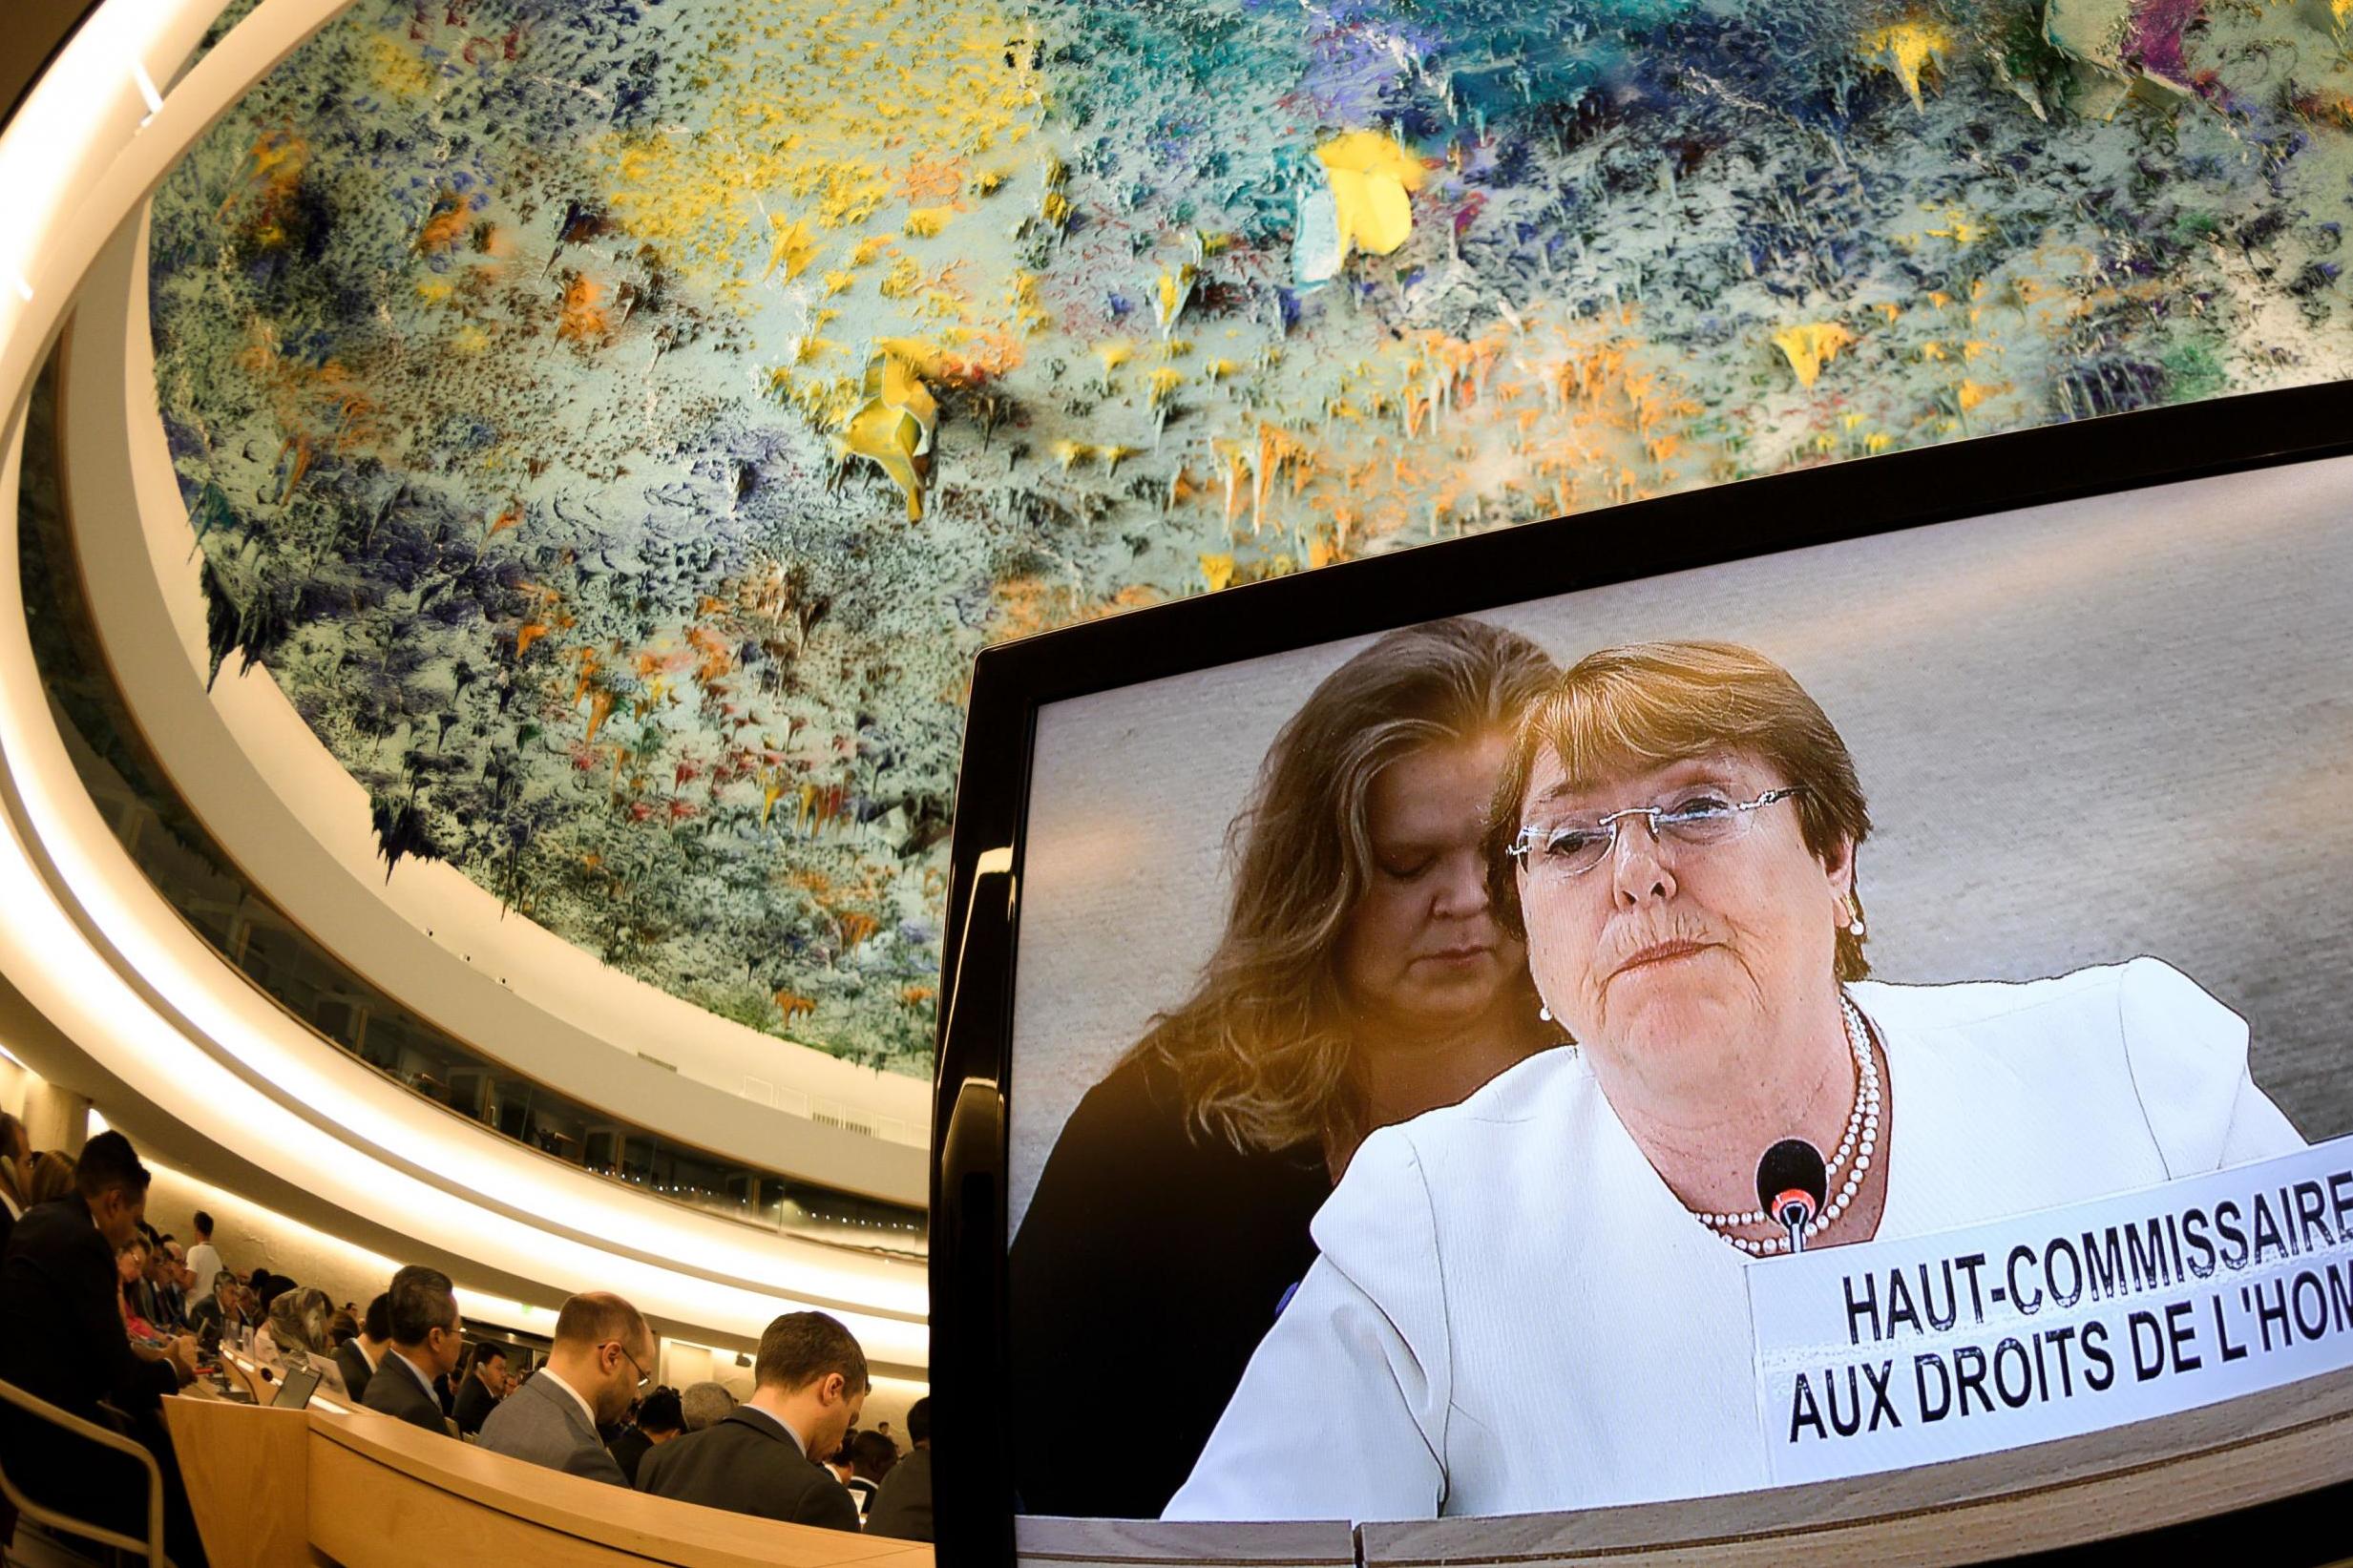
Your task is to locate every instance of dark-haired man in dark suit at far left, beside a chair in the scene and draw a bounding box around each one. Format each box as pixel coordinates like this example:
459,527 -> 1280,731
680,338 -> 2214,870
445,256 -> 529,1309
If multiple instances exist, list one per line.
0,1131 -> 204,1563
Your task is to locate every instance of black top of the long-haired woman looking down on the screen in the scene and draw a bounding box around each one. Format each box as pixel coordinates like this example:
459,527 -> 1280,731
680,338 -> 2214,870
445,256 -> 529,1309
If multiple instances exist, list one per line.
1007,1054 -> 1332,1518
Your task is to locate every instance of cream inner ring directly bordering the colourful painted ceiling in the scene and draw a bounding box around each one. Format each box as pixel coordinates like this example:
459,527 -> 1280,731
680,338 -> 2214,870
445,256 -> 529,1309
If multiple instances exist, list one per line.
20,0 -> 930,1189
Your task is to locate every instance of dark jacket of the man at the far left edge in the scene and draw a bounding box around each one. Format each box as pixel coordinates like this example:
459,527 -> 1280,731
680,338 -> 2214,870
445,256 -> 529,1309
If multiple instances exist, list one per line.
0,1192 -> 179,1425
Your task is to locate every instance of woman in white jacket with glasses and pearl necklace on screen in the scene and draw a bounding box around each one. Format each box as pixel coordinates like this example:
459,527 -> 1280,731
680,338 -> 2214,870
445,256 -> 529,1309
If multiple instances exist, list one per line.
1167,641 -> 2303,1521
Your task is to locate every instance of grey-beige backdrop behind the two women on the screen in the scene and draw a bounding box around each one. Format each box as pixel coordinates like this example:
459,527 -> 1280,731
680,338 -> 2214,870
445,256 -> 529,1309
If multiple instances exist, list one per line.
1012,461 -> 2353,1227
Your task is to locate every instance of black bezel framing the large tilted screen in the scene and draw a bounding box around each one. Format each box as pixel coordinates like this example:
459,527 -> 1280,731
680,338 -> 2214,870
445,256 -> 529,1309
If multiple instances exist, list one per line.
930,384 -> 2353,1563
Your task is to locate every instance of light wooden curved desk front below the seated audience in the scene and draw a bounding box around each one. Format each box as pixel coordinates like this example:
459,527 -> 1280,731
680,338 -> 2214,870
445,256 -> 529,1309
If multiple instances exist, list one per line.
165,1396 -> 932,1568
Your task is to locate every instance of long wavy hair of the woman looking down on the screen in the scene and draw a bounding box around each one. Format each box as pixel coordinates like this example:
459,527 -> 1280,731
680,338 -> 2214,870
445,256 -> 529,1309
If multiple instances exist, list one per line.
1129,618 -> 1558,1152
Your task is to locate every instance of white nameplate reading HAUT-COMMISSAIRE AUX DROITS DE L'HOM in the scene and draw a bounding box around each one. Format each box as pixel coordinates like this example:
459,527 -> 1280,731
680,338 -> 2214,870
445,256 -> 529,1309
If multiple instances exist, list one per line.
1746,1138 -> 2353,1486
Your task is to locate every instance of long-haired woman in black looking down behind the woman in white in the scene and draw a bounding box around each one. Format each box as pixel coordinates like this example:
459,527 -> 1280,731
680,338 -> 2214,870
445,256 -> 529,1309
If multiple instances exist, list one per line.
1009,620 -> 1560,1518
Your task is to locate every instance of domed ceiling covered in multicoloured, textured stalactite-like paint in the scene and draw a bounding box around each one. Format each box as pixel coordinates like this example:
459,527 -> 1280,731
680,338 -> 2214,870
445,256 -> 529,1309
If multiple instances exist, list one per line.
153,0 -> 2353,1072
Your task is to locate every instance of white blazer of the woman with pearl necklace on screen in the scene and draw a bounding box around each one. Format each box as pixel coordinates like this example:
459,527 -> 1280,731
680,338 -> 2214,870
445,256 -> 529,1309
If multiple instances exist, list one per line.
1165,959 -> 2303,1521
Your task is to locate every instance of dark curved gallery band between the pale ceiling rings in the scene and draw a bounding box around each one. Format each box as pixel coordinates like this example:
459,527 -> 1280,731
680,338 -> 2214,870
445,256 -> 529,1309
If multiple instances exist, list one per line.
19,357 -> 925,1258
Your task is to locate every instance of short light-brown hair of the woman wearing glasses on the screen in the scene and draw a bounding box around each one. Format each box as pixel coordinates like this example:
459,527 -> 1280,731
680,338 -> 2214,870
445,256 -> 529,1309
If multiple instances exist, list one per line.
1487,641 -> 1871,980
